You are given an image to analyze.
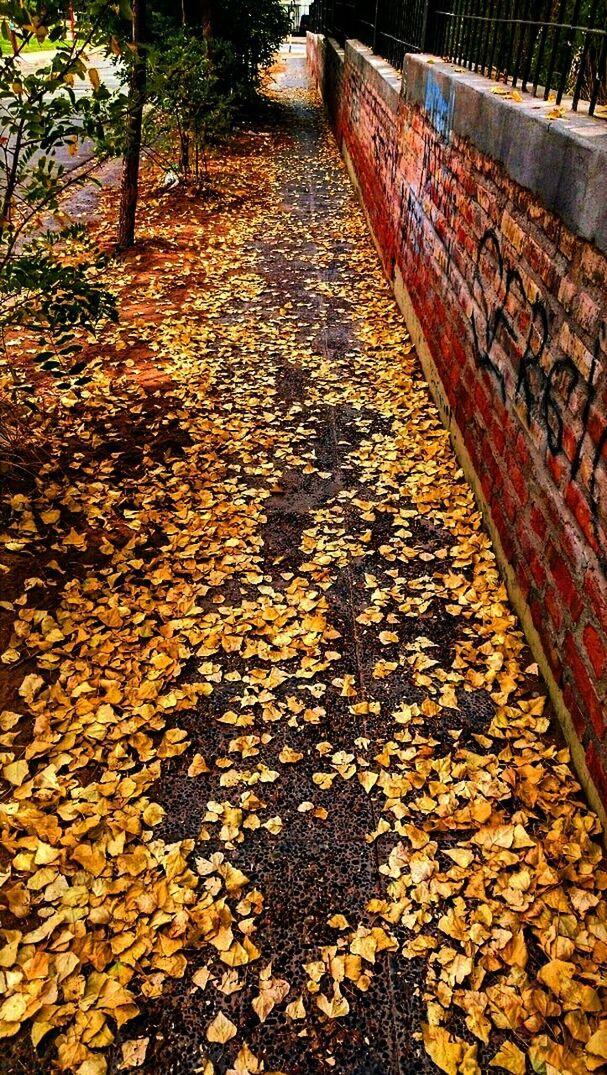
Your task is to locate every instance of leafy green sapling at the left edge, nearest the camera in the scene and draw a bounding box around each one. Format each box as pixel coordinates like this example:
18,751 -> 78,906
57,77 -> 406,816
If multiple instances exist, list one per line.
0,0 -> 121,399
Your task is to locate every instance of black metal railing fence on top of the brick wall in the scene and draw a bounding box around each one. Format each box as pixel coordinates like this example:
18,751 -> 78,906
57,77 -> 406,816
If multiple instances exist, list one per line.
310,0 -> 607,115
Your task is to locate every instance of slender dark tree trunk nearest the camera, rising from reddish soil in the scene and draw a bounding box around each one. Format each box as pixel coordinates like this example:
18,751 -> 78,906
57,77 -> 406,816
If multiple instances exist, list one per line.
118,0 -> 146,250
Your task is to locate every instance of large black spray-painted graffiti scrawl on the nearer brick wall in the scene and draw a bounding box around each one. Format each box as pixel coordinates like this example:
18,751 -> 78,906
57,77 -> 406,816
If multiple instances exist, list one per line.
472,229 -> 607,518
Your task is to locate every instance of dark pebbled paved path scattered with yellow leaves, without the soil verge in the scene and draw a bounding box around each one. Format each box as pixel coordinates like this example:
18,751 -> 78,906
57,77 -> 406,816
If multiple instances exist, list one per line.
0,58 -> 607,1075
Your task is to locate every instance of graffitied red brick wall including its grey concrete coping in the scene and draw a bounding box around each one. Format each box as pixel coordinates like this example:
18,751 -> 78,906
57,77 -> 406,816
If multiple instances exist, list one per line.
308,34 -> 607,821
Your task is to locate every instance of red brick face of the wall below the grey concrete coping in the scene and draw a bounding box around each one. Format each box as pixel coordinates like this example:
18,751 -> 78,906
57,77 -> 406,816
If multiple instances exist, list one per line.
317,39 -> 607,802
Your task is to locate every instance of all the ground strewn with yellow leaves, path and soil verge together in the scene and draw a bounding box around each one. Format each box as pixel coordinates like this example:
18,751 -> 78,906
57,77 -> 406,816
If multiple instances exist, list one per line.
0,54 -> 607,1075
